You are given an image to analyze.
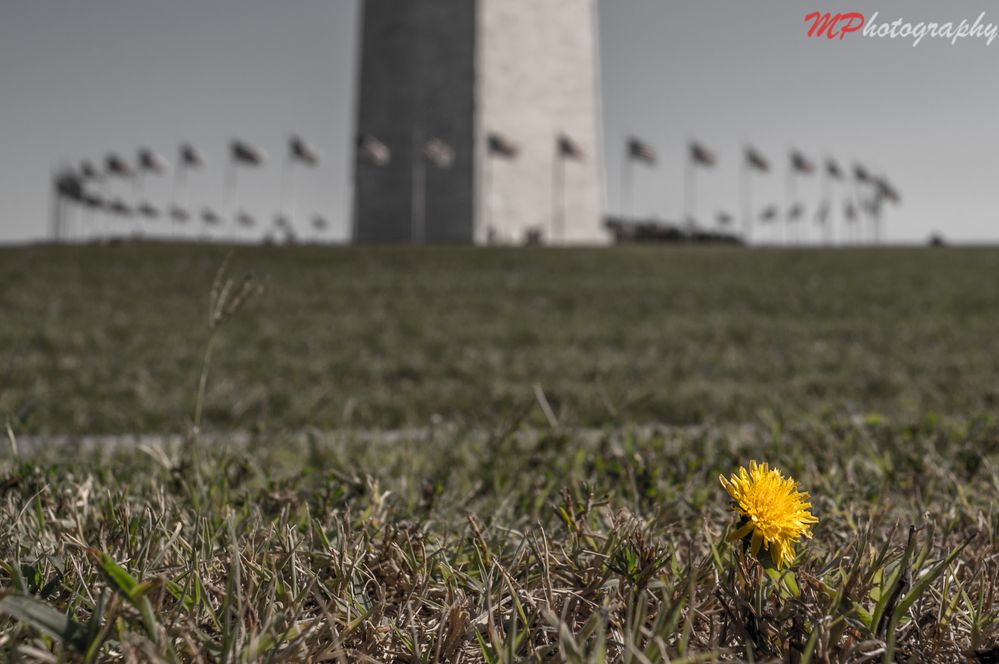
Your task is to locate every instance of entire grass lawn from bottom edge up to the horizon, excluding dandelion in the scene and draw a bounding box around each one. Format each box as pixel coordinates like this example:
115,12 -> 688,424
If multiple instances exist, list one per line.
0,245 -> 999,664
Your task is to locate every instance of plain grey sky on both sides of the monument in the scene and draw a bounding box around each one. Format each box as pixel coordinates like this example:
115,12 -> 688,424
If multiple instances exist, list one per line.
0,0 -> 999,243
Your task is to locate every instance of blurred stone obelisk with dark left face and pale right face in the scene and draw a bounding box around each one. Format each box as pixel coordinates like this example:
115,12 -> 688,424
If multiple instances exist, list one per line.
354,0 -> 606,244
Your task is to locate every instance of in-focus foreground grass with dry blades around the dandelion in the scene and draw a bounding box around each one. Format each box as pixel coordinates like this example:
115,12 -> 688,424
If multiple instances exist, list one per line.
0,420 -> 999,664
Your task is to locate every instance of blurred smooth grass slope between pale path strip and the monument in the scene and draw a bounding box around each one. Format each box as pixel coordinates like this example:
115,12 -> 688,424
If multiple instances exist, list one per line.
0,245 -> 999,434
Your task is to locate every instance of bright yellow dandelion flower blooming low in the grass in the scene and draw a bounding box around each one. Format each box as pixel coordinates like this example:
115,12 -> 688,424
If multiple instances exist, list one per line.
718,461 -> 819,568
